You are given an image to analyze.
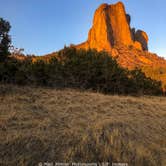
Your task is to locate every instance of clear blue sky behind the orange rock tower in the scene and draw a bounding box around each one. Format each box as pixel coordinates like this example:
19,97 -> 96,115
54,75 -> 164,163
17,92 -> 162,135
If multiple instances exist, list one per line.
0,0 -> 166,57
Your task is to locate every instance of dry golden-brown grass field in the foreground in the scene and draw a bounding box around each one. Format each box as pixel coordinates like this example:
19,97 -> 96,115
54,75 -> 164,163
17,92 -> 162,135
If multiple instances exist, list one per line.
0,85 -> 166,166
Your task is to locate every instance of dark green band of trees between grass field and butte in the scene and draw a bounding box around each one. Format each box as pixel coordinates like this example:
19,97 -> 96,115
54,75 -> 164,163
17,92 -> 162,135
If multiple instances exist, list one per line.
0,17 -> 162,95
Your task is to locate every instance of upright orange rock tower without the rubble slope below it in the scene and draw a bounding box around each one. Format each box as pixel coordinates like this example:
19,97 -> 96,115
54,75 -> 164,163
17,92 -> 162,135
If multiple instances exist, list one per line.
76,2 -> 148,52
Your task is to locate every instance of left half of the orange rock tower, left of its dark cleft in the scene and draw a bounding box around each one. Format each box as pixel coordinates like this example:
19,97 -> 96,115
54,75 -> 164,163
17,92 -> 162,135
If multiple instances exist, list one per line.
78,4 -> 114,51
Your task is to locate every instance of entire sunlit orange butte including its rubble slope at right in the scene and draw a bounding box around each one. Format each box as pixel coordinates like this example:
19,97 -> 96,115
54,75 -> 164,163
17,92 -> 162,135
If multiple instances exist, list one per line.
75,2 -> 166,90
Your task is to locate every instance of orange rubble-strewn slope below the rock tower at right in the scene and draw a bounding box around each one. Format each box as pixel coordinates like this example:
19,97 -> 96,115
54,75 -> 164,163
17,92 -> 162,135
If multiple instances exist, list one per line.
113,46 -> 166,91
